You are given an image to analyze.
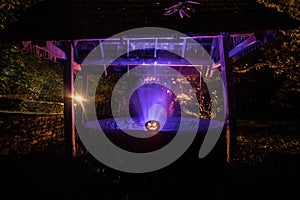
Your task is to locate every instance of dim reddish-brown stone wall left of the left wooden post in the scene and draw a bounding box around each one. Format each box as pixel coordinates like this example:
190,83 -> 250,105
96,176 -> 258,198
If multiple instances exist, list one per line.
0,113 -> 64,156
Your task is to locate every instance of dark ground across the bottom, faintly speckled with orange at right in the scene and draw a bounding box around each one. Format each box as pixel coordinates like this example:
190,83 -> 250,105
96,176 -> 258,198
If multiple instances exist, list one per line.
0,120 -> 300,200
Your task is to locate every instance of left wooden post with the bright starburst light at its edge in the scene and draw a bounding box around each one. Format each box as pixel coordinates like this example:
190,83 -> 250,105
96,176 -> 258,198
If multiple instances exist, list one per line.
62,42 -> 76,158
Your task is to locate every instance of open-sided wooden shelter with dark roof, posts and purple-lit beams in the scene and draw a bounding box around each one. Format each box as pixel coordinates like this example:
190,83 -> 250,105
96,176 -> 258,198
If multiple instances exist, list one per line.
1,0 -> 299,162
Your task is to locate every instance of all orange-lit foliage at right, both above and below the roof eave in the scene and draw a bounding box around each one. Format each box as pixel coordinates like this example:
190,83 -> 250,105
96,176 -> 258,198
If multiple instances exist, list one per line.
234,0 -> 300,111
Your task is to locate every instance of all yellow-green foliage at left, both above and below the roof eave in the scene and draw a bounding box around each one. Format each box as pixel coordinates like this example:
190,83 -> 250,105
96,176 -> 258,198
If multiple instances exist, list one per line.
0,0 -> 63,112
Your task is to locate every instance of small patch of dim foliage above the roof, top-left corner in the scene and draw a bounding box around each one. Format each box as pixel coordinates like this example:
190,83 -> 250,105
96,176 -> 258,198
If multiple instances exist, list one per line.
0,0 -> 43,30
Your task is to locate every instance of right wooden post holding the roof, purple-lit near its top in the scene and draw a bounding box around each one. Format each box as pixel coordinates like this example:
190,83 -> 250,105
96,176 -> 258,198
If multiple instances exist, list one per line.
219,32 -> 237,163
